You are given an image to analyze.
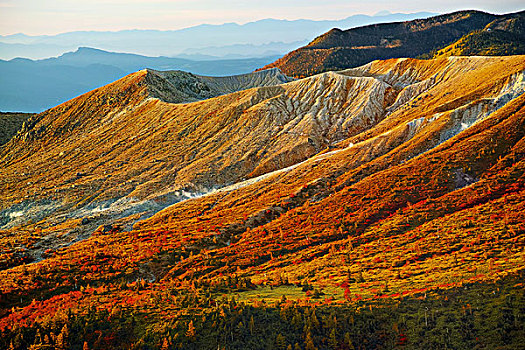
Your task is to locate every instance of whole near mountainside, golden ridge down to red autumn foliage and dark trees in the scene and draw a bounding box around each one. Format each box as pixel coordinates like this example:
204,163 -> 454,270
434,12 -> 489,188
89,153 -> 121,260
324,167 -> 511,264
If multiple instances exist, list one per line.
0,56 -> 525,349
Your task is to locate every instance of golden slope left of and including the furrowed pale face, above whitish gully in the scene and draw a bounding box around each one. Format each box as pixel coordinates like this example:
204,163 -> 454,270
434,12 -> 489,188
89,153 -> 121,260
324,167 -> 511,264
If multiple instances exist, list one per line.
2,67 -> 395,232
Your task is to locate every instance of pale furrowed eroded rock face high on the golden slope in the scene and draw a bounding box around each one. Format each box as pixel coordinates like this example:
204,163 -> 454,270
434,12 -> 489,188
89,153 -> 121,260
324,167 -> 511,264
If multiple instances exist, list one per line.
252,73 -> 389,143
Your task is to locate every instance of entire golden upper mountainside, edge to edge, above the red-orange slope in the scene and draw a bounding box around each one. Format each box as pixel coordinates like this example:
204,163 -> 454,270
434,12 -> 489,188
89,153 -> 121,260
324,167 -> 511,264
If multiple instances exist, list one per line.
0,56 -> 525,265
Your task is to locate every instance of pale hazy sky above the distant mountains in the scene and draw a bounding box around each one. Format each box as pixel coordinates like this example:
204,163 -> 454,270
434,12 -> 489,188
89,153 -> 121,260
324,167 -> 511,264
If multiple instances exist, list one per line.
0,0 -> 525,35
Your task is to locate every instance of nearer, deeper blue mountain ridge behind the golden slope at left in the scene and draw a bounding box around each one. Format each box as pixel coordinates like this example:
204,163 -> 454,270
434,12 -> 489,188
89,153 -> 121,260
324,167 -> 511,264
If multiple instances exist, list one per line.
0,47 -> 278,112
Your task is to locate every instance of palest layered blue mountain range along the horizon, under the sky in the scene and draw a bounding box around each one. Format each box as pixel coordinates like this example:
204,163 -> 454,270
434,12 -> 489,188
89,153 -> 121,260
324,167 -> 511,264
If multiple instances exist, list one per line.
0,12 -> 435,59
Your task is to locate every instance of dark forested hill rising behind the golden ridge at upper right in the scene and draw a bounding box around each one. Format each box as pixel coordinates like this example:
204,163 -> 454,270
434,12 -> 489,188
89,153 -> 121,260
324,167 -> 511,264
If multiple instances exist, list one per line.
263,11 -> 523,77
